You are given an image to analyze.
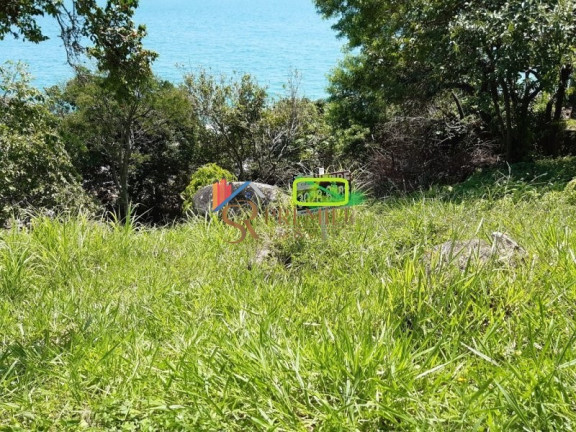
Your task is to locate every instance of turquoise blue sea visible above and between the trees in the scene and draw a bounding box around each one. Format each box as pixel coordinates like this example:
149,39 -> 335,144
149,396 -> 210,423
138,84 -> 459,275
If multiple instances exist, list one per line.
0,0 -> 345,99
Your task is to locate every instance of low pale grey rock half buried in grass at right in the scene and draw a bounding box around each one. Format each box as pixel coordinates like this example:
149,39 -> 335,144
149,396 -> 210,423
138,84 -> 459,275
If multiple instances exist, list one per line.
424,232 -> 526,270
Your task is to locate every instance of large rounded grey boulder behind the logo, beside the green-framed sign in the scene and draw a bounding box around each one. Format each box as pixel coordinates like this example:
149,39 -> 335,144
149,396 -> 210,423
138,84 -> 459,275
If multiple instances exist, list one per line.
192,182 -> 286,216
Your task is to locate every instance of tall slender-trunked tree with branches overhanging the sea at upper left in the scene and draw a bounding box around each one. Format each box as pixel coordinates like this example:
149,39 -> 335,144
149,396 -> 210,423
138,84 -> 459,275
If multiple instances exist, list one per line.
0,0 -> 157,214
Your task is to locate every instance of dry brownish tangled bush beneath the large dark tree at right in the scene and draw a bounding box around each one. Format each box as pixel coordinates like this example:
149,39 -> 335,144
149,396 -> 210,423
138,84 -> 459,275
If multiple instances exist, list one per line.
367,117 -> 498,196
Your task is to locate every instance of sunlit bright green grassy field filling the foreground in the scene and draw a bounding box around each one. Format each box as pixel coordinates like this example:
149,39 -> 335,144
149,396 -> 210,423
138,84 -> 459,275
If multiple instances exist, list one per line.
0,159 -> 576,431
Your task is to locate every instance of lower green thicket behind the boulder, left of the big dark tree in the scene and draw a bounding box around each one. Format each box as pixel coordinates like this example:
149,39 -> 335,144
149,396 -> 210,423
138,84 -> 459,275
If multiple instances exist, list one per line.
0,60 -> 336,223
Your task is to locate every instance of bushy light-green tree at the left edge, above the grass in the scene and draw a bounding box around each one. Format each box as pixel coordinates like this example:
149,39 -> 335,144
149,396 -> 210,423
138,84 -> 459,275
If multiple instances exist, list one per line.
0,64 -> 92,222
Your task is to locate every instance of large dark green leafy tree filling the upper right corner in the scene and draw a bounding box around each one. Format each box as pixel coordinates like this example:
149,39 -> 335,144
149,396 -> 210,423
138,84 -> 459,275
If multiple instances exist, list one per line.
316,0 -> 576,161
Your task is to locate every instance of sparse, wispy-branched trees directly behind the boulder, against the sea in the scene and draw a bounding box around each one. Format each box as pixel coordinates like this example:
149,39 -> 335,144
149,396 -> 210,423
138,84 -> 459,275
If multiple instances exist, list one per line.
185,72 -> 336,183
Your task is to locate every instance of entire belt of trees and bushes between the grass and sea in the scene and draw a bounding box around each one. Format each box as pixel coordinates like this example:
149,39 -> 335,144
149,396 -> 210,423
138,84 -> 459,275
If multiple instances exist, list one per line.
0,0 -> 576,223
